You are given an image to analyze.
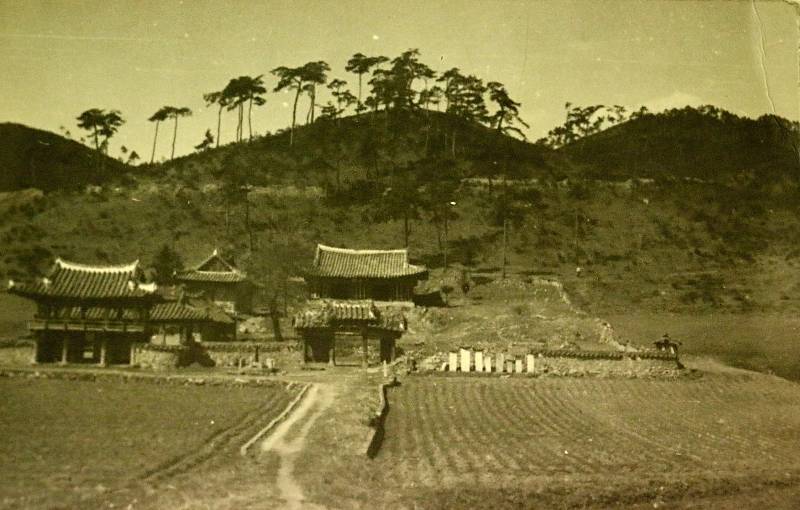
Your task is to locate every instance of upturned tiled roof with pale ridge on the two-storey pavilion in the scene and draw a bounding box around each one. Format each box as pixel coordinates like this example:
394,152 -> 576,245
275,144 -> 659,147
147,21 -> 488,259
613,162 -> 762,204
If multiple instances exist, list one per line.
9,258 -> 156,299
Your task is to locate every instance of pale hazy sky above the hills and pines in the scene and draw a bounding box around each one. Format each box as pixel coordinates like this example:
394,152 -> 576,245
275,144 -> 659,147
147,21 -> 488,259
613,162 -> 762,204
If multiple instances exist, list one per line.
0,0 -> 800,159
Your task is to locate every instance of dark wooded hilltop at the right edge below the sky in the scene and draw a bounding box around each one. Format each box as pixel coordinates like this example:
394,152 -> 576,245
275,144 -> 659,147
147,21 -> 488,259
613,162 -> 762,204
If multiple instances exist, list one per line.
560,106 -> 800,185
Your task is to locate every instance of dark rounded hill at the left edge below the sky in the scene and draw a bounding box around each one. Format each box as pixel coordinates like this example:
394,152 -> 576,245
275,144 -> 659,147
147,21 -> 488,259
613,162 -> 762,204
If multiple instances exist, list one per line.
0,122 -> 127,191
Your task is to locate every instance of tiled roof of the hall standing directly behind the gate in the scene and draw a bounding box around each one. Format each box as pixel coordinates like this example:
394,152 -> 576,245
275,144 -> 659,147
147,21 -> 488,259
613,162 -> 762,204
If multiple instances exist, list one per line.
310,244 -> 426,278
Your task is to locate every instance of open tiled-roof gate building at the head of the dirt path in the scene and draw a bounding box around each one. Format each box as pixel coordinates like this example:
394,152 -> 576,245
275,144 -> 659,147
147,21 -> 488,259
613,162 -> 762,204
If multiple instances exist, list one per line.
292,300 -> 408,367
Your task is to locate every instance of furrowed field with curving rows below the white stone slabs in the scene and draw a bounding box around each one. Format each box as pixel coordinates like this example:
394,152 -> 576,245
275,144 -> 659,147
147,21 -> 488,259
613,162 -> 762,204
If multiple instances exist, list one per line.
378,372 -> 800,507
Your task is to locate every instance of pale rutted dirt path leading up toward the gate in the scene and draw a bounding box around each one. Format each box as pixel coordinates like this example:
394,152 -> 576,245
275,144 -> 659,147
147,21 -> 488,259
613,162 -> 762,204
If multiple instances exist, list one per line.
261,383 -> 335,509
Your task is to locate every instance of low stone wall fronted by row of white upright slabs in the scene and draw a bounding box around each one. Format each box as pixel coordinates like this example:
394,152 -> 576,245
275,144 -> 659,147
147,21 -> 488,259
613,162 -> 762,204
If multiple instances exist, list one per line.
437,349 -> 682,377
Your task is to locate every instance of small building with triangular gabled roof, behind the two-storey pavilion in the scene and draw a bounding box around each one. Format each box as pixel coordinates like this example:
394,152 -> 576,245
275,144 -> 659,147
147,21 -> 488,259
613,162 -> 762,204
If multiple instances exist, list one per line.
175,250 -> 255,315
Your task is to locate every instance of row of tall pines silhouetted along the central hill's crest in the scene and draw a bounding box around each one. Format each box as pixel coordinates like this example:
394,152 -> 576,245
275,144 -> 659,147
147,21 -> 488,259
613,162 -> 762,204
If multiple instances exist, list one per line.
78,49 -> 529,164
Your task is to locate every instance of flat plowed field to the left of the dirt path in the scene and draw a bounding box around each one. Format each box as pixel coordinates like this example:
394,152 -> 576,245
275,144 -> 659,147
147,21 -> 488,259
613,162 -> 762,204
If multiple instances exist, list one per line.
0,378 -> 295,509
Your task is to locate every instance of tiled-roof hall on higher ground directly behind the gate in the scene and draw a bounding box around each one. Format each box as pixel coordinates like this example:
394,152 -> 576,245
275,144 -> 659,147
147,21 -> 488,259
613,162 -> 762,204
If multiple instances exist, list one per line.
307,244 -> 428,301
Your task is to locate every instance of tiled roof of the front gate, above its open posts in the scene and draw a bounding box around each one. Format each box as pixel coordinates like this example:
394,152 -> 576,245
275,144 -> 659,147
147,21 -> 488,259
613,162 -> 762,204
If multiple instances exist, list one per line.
292,300 -> 406,332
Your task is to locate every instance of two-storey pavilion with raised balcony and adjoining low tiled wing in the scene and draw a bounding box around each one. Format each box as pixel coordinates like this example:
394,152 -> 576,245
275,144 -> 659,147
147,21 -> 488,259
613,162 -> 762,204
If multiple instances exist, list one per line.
8,258 -> 232,365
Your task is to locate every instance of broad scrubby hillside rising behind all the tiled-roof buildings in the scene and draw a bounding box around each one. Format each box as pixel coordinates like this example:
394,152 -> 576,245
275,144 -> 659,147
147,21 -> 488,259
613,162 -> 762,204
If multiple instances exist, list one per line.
0,107 -> 800,311
